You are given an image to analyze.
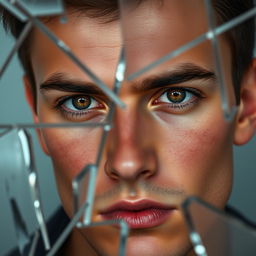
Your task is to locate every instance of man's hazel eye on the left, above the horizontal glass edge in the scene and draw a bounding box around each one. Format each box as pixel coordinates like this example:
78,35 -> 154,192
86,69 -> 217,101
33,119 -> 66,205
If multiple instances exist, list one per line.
56,95 -> 106,121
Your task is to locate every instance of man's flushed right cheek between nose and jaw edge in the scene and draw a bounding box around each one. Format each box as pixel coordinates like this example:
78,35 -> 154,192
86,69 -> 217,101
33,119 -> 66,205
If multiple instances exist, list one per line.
154,113 -> 233,206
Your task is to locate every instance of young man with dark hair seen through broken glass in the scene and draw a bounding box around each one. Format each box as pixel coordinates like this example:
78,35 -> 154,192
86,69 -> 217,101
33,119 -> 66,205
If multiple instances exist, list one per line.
0,0 -> 256,256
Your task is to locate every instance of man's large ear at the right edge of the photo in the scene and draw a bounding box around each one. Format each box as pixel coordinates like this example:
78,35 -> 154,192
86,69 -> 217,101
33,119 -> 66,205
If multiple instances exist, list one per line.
234,59 -> 256,145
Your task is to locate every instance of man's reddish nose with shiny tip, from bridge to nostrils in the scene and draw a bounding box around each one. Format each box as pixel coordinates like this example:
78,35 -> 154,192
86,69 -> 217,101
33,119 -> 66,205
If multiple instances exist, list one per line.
105,105 -> 157,182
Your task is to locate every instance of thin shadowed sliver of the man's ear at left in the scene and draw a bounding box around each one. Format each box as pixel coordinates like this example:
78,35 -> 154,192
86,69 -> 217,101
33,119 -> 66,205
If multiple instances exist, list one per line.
23,75 -> 49,155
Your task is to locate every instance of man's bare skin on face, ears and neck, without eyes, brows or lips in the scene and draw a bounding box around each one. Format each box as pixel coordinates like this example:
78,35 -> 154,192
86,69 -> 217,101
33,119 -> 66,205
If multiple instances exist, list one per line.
25,1 -> 256,256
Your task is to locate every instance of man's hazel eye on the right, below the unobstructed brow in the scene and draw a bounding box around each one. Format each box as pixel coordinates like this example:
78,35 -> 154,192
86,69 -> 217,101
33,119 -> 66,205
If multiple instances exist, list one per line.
153,87 -> 204,113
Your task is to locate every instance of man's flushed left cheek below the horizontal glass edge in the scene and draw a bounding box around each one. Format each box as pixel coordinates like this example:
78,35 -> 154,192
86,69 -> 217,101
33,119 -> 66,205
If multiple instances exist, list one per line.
39,128 -> 102,215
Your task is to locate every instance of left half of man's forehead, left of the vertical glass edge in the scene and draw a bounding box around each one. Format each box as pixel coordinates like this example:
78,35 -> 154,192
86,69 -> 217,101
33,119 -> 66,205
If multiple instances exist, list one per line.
30,14 -> 121,84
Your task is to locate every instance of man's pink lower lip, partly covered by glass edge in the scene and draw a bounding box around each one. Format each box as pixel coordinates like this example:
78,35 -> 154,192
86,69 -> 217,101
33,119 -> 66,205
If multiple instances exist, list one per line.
102,208 -> 172,229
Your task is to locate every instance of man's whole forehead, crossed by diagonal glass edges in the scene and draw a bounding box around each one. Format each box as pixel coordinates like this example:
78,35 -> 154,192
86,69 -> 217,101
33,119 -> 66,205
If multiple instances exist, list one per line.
31,0 -> 222,87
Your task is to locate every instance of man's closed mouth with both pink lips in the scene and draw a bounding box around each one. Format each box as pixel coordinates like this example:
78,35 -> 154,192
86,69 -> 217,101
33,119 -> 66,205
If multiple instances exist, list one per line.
100,199 -> 177,229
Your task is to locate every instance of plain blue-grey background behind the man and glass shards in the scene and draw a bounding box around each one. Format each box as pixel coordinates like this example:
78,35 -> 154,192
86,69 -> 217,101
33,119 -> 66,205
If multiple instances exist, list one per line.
0,23 -> 256,255
